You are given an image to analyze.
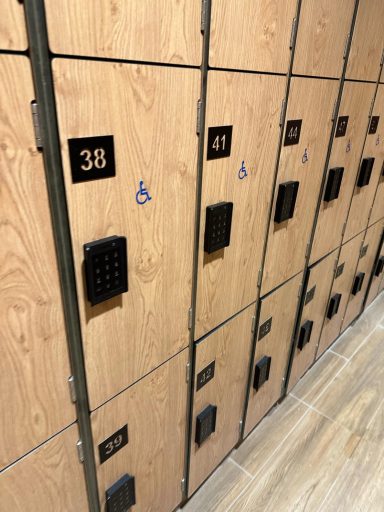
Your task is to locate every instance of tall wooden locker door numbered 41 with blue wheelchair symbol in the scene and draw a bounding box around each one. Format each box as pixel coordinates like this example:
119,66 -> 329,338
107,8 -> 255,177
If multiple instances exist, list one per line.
196,71 -> 285,339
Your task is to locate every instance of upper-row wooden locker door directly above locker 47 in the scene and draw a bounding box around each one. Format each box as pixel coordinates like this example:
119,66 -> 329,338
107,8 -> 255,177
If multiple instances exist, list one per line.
345,0 -> 384,82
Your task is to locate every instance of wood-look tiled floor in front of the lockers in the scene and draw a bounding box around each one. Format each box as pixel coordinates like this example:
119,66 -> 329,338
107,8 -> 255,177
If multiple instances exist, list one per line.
182,293 -> 384,512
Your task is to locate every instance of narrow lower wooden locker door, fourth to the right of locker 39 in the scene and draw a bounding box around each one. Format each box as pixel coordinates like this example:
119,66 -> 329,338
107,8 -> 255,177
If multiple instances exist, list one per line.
316,233 -> 364,358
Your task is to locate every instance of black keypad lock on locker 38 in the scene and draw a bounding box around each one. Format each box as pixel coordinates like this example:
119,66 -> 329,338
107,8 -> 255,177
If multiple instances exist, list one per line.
84,236 -> 128,306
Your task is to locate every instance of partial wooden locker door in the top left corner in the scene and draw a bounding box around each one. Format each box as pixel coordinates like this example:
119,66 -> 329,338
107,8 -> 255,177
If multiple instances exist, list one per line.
0,0 -> 28,51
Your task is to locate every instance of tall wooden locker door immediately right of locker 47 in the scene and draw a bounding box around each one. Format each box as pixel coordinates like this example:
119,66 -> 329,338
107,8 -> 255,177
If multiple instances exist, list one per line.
344,85 -> 384,241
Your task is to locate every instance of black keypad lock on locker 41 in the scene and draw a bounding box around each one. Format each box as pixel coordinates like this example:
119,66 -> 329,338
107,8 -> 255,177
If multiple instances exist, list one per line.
204,202 -> 233,254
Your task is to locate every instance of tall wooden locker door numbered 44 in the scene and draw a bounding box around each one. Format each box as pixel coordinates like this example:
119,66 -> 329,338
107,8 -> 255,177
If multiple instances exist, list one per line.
262,78 -> 338,295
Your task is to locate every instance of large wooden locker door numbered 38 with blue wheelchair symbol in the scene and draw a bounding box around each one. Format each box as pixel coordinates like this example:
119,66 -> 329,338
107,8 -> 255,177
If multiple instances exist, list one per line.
53,59 -> 200,409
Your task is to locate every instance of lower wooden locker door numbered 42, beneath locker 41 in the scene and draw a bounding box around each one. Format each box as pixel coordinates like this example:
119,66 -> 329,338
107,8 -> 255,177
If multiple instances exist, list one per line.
189,304 -> 255,495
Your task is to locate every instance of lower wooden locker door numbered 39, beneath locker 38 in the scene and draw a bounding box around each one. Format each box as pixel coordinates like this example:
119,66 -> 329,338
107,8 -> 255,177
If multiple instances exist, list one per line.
91,349 -> 188,512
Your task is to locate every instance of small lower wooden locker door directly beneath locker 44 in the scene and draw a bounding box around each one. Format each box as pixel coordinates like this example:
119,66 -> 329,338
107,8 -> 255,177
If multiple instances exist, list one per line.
244,274 -> 303,435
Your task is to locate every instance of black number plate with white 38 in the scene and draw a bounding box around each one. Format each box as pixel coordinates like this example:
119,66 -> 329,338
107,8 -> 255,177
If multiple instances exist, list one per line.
68,135 -> 116,183
